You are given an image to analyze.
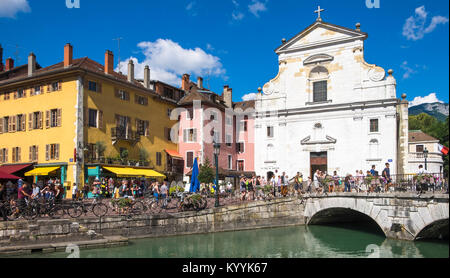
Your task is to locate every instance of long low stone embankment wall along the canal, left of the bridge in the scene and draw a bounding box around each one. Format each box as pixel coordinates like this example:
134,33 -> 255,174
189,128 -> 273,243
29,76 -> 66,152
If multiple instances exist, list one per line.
0,198 -> 305,248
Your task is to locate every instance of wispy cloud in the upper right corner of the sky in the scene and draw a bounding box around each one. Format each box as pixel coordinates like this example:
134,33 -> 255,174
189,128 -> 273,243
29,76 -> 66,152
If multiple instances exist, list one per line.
403,6 -> 448,41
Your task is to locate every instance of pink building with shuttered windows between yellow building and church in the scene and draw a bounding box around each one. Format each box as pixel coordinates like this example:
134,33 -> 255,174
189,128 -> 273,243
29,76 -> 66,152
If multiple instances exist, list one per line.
178,74 -> 255,180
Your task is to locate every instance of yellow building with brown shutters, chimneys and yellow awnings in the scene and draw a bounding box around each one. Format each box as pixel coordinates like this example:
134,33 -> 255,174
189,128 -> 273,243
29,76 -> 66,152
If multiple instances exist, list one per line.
0,44 -> 183,195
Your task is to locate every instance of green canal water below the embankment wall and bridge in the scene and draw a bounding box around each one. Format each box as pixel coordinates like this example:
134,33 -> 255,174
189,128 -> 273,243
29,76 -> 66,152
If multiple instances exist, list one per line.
19,226 -> 449,258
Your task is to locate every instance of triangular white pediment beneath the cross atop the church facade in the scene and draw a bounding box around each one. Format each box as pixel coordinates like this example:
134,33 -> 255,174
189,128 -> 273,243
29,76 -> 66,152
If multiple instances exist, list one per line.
275,21 -> 367,54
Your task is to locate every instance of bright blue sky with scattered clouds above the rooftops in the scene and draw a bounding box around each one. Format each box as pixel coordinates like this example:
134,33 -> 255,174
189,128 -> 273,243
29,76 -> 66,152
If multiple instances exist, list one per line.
0,0 -> 449,105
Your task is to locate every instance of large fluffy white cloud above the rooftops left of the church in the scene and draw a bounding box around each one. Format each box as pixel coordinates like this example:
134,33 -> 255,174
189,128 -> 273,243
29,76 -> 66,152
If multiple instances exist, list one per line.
116,39 -> 226,86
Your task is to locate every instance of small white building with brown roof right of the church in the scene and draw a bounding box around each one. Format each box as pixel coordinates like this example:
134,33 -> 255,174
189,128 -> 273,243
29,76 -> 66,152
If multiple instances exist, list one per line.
408,130 -> 444,174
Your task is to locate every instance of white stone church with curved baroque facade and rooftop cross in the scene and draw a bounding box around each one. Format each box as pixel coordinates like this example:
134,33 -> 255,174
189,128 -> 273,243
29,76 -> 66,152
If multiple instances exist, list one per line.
255,11 -> 408,178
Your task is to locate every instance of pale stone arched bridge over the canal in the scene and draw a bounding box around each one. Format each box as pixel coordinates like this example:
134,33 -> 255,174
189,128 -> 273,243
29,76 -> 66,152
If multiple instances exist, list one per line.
304,193 -> 449,240
